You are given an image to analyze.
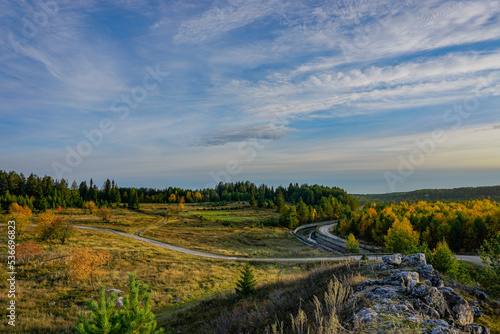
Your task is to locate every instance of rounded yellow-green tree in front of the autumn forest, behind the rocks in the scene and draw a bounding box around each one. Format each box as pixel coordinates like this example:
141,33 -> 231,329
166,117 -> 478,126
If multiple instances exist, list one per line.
385,217 -> 419,253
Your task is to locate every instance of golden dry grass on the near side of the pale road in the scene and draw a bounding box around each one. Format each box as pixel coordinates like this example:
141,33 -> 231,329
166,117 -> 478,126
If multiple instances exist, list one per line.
0,213 -> 326,333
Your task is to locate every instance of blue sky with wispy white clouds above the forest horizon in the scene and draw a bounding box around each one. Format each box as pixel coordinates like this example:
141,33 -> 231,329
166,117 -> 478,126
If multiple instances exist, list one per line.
0,0 -> 500,193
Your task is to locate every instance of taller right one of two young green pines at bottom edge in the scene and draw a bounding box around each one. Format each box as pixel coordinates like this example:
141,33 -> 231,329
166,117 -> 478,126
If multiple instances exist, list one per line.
120,273 -> 163,334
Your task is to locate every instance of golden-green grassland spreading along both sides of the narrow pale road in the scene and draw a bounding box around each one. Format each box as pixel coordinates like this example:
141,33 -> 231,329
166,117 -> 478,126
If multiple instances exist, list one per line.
0,204 -> 332,333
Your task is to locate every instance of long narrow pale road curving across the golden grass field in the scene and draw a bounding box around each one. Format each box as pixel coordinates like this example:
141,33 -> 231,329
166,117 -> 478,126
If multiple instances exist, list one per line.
75,226 -> 482,265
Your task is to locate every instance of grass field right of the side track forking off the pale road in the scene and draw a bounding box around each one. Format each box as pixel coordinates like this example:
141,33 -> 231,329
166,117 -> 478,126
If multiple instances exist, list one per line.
141,206 -> 329,258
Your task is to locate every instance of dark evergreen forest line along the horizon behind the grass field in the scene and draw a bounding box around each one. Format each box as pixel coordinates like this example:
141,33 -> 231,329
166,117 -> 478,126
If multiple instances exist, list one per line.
0,171 -> 358,214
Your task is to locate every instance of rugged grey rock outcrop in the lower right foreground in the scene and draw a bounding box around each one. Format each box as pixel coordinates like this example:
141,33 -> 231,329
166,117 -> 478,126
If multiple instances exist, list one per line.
349,254 -> 490,334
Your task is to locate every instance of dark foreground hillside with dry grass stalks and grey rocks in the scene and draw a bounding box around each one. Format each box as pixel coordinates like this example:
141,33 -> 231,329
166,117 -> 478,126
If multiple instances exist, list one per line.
159,254 -> 500,334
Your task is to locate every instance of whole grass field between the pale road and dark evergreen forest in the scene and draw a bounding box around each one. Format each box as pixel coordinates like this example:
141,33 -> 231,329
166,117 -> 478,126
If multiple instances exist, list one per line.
55,204 -> 329,258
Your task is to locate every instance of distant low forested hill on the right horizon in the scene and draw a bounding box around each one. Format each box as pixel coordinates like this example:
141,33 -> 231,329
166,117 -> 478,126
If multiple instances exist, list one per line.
354,186 -> 500,204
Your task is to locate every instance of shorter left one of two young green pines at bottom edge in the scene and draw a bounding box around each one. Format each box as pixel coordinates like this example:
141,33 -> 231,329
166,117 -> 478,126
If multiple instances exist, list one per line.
76,286 -> 122,334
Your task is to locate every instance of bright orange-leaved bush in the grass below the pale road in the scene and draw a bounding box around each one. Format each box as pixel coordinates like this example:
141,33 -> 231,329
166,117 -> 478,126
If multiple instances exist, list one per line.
67,247 -> 112,288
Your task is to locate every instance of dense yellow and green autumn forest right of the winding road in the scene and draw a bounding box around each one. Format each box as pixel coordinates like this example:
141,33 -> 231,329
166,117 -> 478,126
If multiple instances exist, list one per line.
338,199 -> 500,252
